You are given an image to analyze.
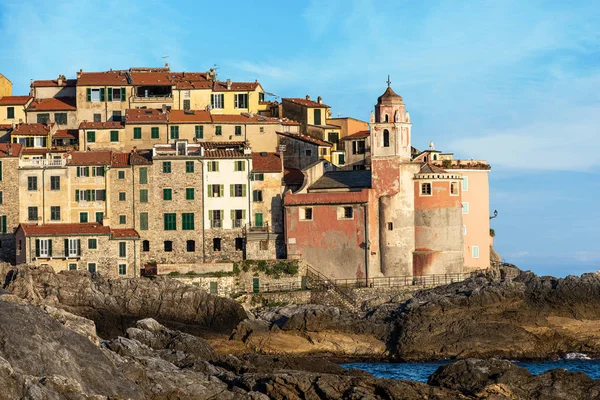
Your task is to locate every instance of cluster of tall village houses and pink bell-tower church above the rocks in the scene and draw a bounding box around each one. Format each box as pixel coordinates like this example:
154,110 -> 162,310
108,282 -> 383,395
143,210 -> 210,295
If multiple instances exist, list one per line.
0,65 -> 492,289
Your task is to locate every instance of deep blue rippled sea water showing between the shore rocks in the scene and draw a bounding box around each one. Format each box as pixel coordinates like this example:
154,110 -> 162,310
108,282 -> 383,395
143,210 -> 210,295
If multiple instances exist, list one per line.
341,360 -> 600,382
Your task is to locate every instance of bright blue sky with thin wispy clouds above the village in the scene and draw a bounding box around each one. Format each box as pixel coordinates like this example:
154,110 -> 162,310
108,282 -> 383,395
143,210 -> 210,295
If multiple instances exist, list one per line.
0,0 -> 600,276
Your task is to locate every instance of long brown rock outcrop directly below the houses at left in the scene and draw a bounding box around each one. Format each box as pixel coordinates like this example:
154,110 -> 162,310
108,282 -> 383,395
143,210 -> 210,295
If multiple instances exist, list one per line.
5,265 -> 246,338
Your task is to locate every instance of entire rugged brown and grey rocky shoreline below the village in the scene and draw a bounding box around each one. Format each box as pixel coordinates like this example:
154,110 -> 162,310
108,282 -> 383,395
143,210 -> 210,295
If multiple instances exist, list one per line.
0,266 -> 600,399
